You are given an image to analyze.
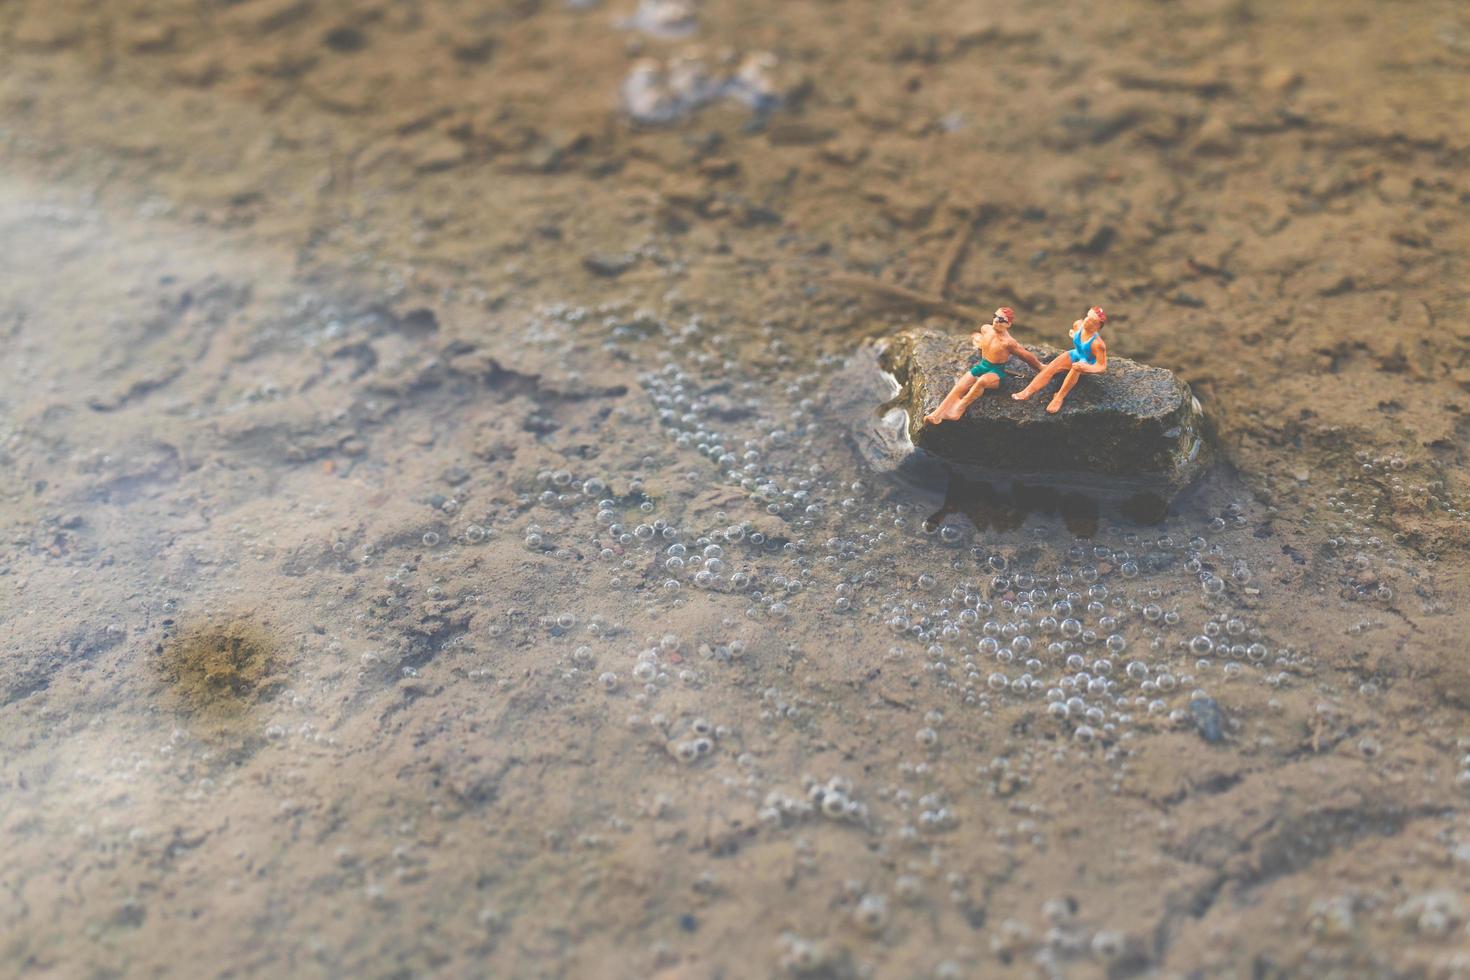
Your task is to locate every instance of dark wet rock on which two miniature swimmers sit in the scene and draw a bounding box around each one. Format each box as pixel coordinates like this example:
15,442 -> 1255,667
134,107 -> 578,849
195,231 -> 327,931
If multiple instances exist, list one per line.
881,329 -> 1211,502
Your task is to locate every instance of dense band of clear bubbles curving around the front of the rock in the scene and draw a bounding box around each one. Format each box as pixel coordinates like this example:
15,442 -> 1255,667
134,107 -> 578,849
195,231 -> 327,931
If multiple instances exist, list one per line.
485,359 -> 1310,751
